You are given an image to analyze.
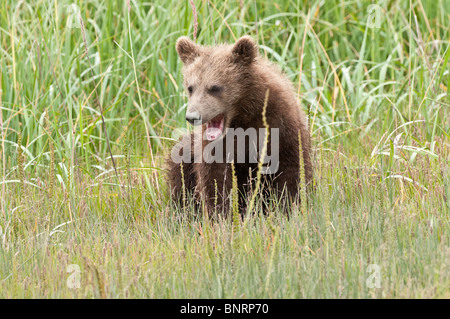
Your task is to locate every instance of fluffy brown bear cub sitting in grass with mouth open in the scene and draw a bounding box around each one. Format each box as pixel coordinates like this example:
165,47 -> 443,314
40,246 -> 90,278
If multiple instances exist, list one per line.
167,36 -> 312,215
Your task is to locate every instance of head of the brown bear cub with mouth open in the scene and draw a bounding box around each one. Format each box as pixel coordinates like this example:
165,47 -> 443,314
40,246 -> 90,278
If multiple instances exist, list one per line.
176,36 -> 258,141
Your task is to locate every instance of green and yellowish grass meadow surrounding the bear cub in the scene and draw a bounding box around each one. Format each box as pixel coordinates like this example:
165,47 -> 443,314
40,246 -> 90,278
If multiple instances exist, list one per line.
0,0 -> 450,298
